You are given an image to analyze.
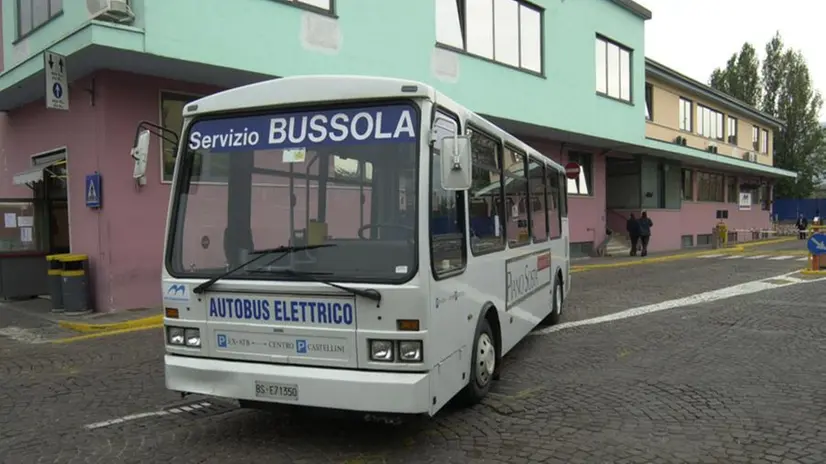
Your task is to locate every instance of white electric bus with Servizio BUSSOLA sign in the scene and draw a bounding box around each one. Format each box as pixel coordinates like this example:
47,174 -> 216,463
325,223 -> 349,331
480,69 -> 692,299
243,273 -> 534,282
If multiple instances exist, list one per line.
148,76 -> 571,415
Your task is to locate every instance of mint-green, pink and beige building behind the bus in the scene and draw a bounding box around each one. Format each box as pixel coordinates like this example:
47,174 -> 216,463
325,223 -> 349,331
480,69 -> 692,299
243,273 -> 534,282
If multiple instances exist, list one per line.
0,0 -> 794,311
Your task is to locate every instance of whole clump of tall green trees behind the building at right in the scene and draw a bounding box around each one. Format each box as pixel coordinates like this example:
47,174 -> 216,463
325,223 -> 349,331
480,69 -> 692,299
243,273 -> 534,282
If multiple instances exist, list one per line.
709,32 -> 826,198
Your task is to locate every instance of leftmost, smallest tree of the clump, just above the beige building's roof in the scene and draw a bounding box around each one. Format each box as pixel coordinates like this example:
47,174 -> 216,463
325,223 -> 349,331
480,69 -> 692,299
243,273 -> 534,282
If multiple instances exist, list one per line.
709,42 -> 761,106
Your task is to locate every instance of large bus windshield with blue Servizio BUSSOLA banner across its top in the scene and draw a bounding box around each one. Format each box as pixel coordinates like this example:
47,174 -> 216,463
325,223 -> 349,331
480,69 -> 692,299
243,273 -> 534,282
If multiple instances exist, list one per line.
166,104 -> 420,283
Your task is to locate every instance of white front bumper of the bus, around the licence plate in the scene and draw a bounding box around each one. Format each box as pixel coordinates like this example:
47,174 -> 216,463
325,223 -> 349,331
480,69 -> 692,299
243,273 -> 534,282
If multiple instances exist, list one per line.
164,354 -> 431,414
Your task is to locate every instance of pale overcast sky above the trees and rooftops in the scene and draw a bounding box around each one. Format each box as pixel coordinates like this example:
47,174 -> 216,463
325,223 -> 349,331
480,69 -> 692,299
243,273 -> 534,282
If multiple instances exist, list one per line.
637,0 -> 826,120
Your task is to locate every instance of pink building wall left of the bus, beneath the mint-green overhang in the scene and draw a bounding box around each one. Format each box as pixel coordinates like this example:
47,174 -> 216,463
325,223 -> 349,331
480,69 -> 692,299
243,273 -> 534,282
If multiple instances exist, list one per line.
0,71 -> 219,311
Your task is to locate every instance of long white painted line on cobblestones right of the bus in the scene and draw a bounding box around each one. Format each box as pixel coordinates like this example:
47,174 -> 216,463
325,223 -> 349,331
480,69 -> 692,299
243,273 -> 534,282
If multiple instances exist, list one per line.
531,271 -> 826,335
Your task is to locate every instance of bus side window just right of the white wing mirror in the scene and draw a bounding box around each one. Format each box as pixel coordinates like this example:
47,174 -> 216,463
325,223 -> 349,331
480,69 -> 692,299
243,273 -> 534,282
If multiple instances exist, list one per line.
468,129 -> 507,255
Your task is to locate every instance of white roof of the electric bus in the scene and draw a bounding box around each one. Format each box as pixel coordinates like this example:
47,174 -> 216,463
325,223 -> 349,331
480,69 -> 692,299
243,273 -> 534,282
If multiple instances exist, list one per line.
184,75 -> 563,171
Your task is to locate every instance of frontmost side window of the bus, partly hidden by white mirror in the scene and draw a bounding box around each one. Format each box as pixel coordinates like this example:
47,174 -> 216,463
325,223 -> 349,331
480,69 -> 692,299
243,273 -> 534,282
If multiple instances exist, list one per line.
430,113 -> 467,278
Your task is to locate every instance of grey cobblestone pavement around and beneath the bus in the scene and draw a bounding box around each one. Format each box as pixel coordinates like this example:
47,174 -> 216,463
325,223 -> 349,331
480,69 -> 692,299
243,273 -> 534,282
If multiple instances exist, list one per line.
0,243 -> 826,464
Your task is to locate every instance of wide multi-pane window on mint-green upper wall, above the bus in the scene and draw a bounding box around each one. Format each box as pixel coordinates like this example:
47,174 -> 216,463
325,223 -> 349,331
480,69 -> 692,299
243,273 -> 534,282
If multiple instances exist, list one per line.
435,0 -> 543,73
